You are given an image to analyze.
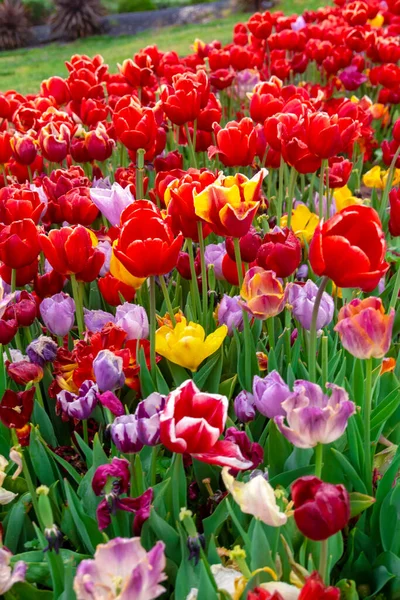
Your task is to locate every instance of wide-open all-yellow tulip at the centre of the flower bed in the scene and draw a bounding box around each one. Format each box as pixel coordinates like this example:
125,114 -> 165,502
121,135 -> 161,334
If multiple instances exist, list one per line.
156,317 -> 228,371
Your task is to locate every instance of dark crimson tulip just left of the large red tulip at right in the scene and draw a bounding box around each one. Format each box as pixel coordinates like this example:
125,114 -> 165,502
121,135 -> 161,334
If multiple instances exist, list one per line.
257,227 -> 301,277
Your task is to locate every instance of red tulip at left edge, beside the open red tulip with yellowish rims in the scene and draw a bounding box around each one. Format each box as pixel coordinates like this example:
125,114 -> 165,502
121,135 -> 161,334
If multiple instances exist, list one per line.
0,219 -> 40,269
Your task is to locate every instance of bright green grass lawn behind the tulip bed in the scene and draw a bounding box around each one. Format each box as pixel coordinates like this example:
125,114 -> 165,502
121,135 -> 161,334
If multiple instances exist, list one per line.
0,0 -> 321,94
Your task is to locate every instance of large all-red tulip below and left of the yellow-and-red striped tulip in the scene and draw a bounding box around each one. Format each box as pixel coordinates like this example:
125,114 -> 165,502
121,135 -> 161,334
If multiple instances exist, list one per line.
114,200 -> 183,277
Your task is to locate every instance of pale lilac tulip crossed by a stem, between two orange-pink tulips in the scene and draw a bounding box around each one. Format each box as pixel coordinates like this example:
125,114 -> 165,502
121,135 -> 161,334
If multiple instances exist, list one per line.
287,279 -> 335,331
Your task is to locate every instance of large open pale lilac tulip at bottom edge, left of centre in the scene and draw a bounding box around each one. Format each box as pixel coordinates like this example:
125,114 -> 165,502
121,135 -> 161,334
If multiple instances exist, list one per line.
74,537 -> 166,600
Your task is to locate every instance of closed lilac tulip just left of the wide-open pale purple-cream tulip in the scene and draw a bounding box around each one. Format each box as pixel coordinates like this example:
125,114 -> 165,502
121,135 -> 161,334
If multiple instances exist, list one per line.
253,371 -> 291,419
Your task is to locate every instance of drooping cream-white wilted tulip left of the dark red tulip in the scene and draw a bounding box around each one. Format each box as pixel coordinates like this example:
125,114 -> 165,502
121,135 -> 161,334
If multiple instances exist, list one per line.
222,467 -> 287,527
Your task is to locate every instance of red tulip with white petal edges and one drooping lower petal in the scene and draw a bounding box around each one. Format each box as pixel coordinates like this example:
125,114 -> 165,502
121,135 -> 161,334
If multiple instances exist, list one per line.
160,379 -> 252,470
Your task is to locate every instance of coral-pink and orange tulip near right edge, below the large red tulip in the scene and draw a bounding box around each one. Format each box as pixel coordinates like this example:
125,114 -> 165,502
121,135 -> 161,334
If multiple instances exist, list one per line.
335,296 -> 395,359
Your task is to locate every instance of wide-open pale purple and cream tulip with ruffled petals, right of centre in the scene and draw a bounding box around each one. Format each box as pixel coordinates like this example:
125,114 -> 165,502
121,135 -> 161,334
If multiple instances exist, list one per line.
275,380 -> 356,448
